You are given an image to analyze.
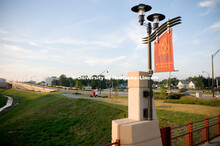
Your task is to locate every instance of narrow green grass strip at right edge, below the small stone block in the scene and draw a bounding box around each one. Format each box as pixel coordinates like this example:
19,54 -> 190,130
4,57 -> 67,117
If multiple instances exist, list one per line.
164,97 -> 220,107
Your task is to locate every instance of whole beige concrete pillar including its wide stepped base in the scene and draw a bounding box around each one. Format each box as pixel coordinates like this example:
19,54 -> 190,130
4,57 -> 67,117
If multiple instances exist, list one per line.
112,72 -> 162,146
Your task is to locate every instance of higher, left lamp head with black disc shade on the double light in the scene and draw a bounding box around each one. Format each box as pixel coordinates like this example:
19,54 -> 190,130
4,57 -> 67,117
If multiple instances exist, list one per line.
131,4 -> 151,25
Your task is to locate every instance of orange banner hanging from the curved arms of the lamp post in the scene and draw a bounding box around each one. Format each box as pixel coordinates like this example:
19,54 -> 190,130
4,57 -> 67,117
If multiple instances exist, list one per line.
154,29 -> 174,72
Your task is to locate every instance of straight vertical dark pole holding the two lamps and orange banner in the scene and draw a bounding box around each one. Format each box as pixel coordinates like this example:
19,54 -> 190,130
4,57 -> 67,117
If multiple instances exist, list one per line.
147,23 -> 153,120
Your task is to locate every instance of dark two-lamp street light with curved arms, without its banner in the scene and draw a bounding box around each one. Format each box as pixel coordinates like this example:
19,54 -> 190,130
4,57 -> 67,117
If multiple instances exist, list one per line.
131,4 -> 181,120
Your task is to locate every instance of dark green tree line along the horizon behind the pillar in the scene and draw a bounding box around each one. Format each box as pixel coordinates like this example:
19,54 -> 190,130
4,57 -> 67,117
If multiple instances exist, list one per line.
52,74 -> 220,89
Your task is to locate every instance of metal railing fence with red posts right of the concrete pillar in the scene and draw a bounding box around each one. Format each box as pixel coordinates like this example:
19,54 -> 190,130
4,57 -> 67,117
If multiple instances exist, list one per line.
161,115 -> 220,146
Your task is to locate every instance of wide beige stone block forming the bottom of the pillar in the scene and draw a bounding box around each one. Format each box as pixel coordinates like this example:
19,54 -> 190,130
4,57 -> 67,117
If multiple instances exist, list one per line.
112,118 -> 162,146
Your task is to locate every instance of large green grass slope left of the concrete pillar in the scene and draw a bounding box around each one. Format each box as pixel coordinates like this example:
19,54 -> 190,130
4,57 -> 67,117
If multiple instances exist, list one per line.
0,89 -> 127,145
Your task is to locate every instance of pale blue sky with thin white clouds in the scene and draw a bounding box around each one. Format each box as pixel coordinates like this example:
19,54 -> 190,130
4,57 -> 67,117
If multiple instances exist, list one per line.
0,0 -> 220,81
